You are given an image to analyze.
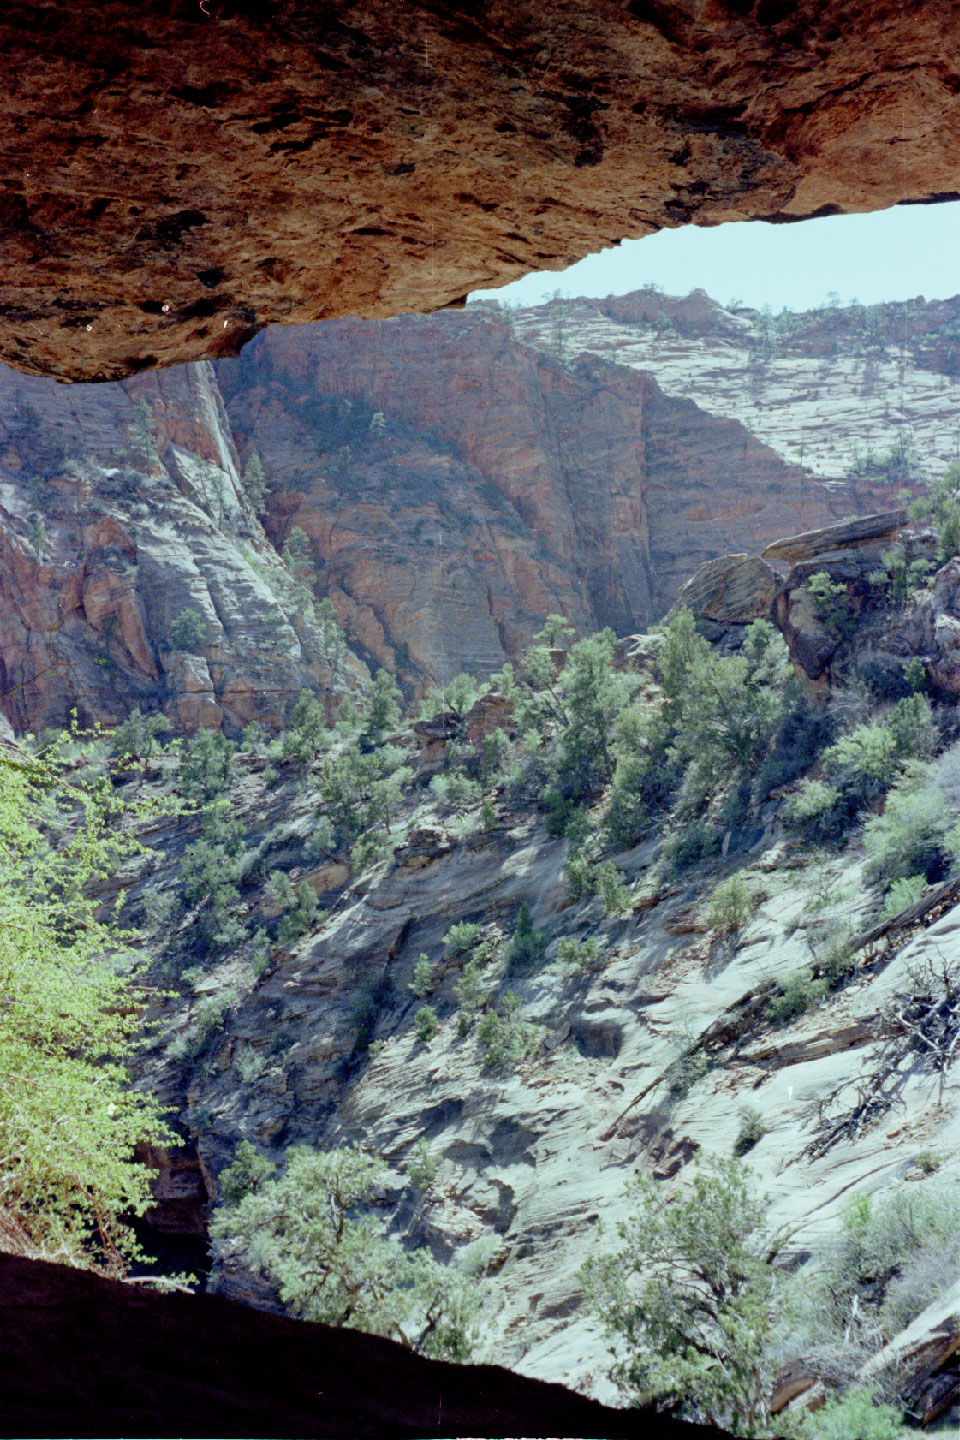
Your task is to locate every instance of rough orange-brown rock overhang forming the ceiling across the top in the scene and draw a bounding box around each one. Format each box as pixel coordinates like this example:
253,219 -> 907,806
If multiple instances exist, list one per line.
0,0 -> 960,379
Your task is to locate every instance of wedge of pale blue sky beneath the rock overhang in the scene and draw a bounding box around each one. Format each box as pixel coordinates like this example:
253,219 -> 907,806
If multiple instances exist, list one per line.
471,202 -> 960,310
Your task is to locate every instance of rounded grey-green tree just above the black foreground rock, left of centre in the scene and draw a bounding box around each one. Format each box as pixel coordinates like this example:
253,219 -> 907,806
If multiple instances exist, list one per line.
210,1145 -> 478,1361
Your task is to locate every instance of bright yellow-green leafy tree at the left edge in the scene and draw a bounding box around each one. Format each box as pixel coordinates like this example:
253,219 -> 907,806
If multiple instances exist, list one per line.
0,755 -> 176,1273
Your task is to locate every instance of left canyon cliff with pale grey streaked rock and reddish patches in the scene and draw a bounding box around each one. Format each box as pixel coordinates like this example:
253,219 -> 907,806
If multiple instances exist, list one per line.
0,363 -> 359,730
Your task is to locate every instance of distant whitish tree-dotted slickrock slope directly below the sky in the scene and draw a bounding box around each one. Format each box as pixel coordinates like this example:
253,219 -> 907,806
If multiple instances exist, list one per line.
514,290 -> 960,483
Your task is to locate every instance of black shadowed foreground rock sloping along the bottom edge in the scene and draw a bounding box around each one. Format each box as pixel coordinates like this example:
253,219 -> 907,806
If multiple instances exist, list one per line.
0,1254 -> 718,1440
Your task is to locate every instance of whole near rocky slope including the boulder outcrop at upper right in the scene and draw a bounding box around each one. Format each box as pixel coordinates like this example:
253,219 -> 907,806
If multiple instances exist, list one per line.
108,516 -> 960,1421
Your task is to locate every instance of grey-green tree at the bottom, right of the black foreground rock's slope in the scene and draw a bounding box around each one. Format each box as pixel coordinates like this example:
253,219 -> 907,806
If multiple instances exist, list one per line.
581,1159 -> 777,1436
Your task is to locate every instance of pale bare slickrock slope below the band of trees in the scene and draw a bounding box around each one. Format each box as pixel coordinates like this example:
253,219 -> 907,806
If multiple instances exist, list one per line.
144,779 -> 960,1400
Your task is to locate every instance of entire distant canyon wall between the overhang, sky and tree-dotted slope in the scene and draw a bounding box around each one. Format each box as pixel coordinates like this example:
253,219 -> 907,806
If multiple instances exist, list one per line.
0,292 -> 932,730
